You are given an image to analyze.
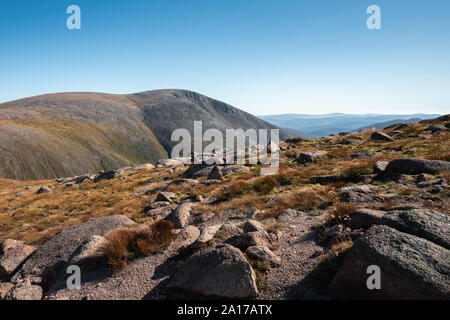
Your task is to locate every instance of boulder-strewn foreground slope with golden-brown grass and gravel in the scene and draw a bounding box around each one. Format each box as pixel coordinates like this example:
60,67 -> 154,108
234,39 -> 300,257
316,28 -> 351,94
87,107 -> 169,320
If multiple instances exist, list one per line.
0,115 -> 450,300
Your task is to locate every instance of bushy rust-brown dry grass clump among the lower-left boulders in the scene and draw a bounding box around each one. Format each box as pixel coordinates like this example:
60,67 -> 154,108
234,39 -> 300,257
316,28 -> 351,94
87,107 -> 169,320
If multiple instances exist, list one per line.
103,220 -> 174,270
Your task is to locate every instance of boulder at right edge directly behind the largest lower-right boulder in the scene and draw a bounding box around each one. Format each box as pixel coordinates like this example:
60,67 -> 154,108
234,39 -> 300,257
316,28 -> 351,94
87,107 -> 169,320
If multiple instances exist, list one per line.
381,209 -> 450,249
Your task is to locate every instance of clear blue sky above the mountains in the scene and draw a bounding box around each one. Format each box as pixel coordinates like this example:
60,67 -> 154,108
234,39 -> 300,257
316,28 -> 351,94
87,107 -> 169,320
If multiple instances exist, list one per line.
0,0 -> 450,115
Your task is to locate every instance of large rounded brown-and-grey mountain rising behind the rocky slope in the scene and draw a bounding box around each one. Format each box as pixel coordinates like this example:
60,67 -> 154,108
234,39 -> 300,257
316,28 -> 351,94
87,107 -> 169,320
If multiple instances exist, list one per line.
0,90 -> 293,179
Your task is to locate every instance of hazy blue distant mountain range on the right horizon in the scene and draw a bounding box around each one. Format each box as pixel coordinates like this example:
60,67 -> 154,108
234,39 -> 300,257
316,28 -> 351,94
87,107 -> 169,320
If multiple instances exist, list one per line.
259,113 -> 440,138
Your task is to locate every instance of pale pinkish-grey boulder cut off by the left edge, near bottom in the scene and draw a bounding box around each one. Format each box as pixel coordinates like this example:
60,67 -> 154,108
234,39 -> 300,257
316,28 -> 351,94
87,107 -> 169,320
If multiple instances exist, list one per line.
0,239 -> 36,277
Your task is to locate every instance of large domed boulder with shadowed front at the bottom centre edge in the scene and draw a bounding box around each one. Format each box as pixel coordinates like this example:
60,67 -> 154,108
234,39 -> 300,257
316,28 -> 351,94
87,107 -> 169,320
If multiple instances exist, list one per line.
168,246 -> 258,298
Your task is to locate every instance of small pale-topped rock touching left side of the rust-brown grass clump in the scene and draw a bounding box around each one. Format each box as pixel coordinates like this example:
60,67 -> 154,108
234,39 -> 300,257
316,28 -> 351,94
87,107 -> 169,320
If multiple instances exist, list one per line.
68,235 -> 108,271
